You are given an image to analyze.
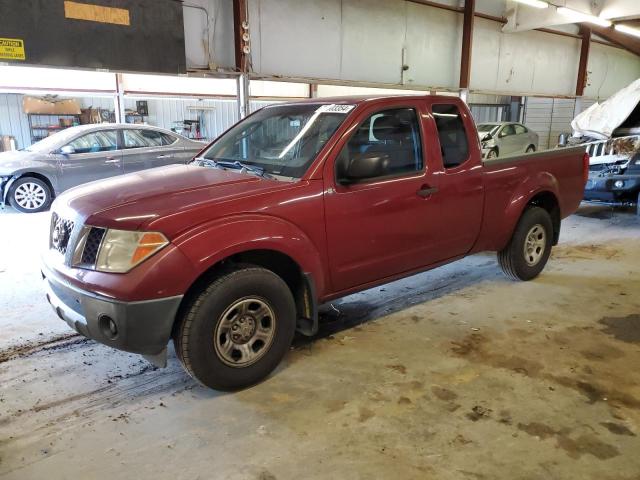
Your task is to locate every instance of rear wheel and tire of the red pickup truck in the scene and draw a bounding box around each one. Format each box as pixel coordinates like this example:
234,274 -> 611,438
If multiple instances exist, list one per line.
498,207 -> 553,281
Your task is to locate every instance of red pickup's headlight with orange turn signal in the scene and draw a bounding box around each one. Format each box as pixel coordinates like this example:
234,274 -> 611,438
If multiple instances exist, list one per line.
96,229 -> 169,273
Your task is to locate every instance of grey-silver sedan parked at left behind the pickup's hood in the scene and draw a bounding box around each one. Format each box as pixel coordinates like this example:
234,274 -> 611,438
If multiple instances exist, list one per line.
0,123 -> 205,213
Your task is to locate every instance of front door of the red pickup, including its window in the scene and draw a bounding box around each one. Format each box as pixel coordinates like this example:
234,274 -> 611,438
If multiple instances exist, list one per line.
324,102 -> 441,290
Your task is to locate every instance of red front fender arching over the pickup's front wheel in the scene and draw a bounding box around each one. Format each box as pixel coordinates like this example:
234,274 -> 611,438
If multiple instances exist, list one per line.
172,213 -> 327,295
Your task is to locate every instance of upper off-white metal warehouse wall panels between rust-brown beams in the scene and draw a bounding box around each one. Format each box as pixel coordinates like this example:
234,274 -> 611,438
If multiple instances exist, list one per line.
248,0 -> 640,97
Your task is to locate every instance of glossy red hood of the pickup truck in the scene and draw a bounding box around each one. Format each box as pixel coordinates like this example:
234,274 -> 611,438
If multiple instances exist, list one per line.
52,165 -> 288,236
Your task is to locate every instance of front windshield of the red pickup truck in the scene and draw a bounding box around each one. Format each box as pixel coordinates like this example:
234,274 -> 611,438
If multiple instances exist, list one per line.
199,104 -> 354,178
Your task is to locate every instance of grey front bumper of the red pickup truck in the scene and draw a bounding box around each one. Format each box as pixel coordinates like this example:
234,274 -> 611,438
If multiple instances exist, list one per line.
42,267 -> 182,366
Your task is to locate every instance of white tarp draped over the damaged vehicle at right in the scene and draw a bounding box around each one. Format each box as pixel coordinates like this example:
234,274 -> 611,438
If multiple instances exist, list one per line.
571,79 -> 640,139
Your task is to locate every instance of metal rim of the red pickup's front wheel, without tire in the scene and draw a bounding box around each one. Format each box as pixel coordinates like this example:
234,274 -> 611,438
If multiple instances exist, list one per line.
213,297 -> 276,368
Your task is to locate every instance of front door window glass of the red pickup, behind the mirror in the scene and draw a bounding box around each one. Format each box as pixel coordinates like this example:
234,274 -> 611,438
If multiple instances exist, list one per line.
337,108 -> 423,179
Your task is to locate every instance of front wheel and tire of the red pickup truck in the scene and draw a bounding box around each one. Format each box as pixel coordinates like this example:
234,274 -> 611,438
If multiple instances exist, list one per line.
173,266 -> 296,391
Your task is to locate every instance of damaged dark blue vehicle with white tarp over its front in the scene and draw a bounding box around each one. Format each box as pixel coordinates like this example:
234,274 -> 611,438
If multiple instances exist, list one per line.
568,80 -> 640,215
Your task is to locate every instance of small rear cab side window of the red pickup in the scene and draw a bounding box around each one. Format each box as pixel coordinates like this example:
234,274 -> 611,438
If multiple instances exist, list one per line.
431,103 -> 469,168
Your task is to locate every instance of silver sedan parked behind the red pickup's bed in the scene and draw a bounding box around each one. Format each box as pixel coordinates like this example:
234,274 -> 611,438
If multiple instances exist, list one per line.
478,122 -> 538,158
